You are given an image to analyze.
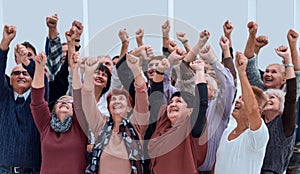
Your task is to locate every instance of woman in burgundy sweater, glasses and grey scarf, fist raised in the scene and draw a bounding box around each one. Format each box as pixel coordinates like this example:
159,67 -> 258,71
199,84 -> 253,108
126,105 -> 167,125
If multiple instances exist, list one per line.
30,53 -> 87,174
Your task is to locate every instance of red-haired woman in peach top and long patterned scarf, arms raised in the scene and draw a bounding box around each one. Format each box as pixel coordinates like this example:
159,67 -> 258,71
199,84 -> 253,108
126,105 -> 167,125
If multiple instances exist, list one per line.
71,51 -> 149,174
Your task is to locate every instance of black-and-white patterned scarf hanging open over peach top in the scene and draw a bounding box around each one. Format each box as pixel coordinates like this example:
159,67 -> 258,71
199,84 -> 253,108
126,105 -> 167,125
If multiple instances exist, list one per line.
85,118 -> 144,174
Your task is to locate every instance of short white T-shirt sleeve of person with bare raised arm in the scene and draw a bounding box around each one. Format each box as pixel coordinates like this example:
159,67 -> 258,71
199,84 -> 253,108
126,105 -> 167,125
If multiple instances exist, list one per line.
247,120 -> 269,151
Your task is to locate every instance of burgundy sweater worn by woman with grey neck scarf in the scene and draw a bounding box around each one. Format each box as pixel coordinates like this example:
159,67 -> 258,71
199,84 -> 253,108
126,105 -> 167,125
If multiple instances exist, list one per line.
30,88 -> 87,174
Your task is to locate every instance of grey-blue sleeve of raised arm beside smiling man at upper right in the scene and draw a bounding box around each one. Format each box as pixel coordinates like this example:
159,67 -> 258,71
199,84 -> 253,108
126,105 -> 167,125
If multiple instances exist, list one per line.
246,56 -> 265,90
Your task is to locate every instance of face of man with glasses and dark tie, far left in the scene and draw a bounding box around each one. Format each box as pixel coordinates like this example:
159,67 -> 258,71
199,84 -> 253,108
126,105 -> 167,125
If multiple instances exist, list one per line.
10,64 -> 32,94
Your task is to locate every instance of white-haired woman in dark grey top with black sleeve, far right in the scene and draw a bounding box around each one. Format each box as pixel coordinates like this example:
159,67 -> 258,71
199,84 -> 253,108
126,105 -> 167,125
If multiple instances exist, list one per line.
261,46 -> 296,174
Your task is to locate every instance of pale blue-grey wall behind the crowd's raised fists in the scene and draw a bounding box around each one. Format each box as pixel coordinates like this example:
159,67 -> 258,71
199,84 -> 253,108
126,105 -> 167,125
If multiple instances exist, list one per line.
0,0 -> 300,75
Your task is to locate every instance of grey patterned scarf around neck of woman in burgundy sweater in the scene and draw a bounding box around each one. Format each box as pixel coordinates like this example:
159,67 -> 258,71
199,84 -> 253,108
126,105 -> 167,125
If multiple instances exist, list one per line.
50,112 -> 72,132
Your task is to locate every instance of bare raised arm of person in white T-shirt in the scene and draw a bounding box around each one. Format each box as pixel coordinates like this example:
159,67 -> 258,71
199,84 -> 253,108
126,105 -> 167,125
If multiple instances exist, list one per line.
235,52 -> 262,131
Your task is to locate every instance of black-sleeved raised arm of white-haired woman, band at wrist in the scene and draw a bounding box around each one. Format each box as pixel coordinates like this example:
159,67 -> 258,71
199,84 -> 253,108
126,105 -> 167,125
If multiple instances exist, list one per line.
275,46 -> 296,137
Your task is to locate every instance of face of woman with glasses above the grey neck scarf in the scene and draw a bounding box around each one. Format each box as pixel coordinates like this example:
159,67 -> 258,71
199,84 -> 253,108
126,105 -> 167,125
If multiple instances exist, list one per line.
54,96 -> 73,118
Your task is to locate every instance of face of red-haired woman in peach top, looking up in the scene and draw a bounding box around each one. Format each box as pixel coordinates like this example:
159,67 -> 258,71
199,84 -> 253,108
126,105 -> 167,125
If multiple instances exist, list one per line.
109,94 -> 131,120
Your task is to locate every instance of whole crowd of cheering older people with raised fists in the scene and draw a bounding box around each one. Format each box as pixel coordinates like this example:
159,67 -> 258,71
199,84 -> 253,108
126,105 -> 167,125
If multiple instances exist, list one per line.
0,14 -> 300,174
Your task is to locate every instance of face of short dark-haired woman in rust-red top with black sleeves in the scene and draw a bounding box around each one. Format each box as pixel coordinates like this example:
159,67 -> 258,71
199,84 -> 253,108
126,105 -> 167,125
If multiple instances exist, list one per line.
167,96 -> 191,125
